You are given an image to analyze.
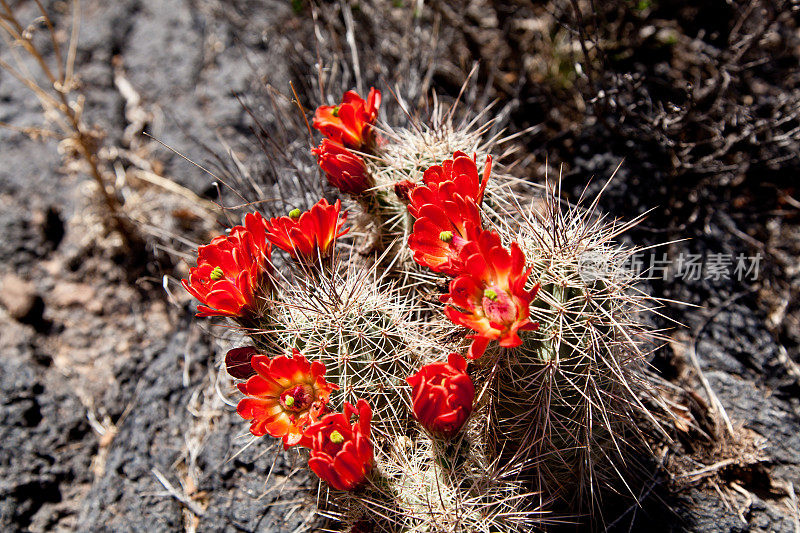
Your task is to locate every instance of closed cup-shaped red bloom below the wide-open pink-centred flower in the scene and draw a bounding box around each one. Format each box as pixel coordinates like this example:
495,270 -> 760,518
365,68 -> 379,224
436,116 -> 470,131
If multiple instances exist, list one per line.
406,353 -> 475,439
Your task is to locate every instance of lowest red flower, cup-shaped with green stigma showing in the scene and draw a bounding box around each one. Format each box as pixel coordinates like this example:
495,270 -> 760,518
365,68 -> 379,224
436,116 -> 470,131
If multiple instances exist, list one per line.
306,400 -> 375,490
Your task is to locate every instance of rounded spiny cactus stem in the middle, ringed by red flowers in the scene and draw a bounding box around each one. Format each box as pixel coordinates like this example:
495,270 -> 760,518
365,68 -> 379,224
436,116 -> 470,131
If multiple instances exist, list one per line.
278,267 -> 416,431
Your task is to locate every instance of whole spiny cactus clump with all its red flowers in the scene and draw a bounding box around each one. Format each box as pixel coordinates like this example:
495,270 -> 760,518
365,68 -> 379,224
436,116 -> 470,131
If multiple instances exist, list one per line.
184,86 -> 668,532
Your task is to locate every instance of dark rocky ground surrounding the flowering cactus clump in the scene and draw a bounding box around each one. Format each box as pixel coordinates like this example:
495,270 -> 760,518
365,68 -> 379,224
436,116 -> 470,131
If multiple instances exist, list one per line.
0,0 -> 800,532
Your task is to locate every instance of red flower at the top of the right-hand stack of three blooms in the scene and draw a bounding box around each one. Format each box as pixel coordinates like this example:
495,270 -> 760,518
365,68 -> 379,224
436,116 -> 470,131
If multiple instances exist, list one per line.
411,152 -> 492,209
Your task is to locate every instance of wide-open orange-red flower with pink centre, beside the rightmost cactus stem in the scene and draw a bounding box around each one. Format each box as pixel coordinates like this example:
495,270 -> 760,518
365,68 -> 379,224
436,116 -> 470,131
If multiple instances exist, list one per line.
442,230 -> 539,359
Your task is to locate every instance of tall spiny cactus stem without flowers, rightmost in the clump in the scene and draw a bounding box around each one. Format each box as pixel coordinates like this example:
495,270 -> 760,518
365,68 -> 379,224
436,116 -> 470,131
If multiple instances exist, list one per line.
484,186 -> 660,512
